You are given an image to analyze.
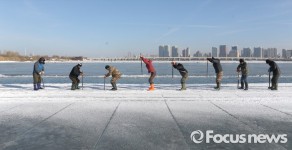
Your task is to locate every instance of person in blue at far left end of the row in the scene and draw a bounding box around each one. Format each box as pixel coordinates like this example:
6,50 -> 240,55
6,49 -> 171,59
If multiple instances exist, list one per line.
32,57 -> 46,90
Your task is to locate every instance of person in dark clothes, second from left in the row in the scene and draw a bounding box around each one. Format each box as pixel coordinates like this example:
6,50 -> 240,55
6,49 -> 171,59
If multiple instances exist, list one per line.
69,63 -> 83,90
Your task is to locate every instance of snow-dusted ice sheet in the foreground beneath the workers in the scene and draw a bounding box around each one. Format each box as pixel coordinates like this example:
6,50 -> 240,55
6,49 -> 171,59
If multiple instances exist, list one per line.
0,83 -> 292,150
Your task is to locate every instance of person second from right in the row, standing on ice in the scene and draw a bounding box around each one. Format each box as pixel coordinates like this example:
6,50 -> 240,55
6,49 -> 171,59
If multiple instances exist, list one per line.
237,59 -> 248,90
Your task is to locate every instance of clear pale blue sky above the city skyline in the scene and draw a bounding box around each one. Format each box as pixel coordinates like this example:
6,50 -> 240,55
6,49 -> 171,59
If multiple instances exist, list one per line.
0,0 -> 292,57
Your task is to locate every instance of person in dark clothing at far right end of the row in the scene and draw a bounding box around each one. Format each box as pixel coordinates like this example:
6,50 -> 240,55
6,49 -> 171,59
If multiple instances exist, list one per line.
266,59 -> 281,90
